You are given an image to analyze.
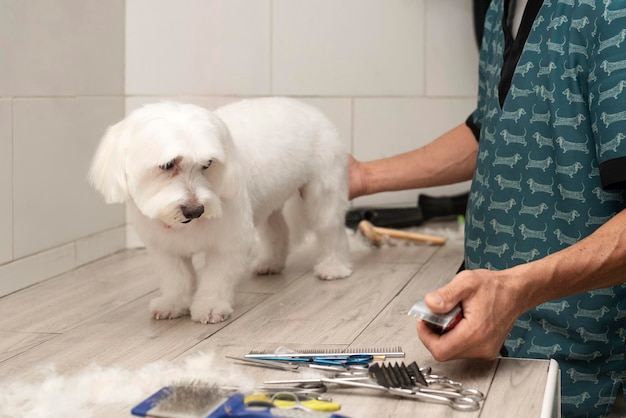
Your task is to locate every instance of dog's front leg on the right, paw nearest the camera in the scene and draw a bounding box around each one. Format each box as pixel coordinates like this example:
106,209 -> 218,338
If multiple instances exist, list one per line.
190,250 -> 248,324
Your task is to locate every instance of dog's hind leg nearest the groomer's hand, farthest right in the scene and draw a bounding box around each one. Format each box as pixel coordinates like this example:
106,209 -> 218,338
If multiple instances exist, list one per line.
301,180 -> 352,280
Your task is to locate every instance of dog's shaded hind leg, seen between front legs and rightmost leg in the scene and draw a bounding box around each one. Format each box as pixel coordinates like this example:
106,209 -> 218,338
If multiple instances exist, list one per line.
254,208 -> 289,274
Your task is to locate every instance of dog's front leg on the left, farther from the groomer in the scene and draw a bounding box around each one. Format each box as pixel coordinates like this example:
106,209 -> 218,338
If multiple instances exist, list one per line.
150,251 -> 196,319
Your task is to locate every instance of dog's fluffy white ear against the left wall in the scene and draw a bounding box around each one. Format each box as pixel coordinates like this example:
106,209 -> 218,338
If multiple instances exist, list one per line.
89,121 -> 128,203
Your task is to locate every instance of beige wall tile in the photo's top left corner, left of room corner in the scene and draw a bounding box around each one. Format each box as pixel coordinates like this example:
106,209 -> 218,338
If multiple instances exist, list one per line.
0,0 -> 124,97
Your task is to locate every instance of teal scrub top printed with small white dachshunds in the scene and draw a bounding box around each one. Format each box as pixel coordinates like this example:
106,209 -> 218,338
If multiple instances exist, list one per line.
465,0 -> 626,417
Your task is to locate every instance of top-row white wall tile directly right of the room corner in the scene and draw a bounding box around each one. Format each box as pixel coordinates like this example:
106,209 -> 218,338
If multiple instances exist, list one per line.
126,0 -> 271,95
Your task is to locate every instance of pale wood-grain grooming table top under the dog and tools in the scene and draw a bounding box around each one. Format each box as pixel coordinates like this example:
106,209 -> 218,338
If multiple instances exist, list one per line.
0,225 -> 549,418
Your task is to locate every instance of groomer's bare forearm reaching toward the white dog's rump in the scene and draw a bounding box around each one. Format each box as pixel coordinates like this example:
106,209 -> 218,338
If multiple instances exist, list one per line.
359,123 -> 478,195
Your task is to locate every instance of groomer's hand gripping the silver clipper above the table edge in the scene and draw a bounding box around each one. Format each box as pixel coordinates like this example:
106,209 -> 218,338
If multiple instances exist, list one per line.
417,270 -> 524,361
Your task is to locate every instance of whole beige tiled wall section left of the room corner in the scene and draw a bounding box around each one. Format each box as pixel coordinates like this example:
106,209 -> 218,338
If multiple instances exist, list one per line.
0,0 -> 125,296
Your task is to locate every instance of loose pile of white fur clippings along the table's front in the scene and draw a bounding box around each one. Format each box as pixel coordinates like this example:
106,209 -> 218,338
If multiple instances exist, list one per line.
0,353 -> 253,418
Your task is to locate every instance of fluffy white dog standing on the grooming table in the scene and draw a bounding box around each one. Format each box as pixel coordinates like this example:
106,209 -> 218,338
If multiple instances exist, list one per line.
89,98 -> 351,323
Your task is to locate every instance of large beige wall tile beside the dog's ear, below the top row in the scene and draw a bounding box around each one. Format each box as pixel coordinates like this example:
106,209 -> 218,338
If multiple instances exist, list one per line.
13,98 -> 124,258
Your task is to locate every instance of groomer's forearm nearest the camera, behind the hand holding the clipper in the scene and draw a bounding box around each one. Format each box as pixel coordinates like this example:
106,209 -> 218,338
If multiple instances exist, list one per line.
511,210 -> 626,310
